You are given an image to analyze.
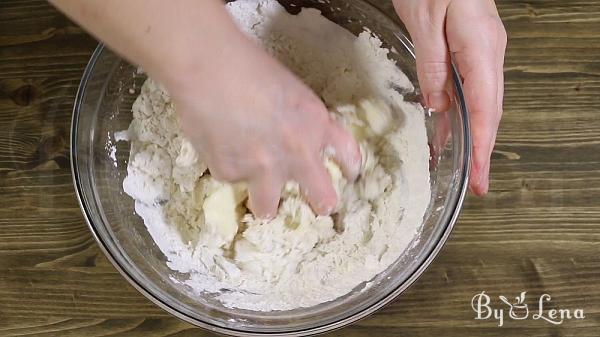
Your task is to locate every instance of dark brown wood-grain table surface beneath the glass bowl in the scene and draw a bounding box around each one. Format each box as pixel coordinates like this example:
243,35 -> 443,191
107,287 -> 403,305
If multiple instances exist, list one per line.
0,0 -> 600,337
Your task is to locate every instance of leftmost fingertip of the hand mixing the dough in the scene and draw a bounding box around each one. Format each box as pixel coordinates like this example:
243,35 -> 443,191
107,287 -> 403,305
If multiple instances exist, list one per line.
248,174 -> 283,220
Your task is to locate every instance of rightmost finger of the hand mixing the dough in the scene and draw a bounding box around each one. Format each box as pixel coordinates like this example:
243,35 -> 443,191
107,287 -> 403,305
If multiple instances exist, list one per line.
326,121 -> 362,181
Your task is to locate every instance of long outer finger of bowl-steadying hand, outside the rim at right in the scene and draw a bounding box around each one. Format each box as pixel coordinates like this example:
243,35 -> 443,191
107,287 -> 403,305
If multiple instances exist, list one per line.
446,1 -> 504,195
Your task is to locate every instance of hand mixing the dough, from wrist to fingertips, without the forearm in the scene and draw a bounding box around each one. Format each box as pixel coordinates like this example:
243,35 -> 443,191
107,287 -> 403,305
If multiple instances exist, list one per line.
167,32 -> 361,219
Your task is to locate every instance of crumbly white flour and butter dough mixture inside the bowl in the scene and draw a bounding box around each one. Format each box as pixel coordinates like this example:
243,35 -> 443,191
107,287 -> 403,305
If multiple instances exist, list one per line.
123,0 -> 430,311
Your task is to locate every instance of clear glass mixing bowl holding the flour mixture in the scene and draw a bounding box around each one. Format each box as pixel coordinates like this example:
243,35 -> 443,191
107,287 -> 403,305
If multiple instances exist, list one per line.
71,0 -> 471,336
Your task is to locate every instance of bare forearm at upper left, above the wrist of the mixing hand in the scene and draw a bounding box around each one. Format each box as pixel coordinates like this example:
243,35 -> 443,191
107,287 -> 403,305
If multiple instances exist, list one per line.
50,0 -> 243,86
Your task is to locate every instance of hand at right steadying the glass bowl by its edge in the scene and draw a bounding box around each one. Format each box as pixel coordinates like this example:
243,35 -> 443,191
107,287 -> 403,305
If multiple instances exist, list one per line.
393,0 -> 507,195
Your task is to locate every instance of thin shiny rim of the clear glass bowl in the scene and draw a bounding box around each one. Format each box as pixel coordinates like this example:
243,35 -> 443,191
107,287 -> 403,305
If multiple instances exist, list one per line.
70,2 -> 472,336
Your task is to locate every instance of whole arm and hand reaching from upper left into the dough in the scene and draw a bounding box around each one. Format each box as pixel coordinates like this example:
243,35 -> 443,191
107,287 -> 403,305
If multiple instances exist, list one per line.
51,0 -> 361,218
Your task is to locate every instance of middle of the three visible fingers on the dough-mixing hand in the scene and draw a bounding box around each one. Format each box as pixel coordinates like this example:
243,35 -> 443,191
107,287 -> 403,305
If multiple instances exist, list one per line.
294,155 -> 337,215
